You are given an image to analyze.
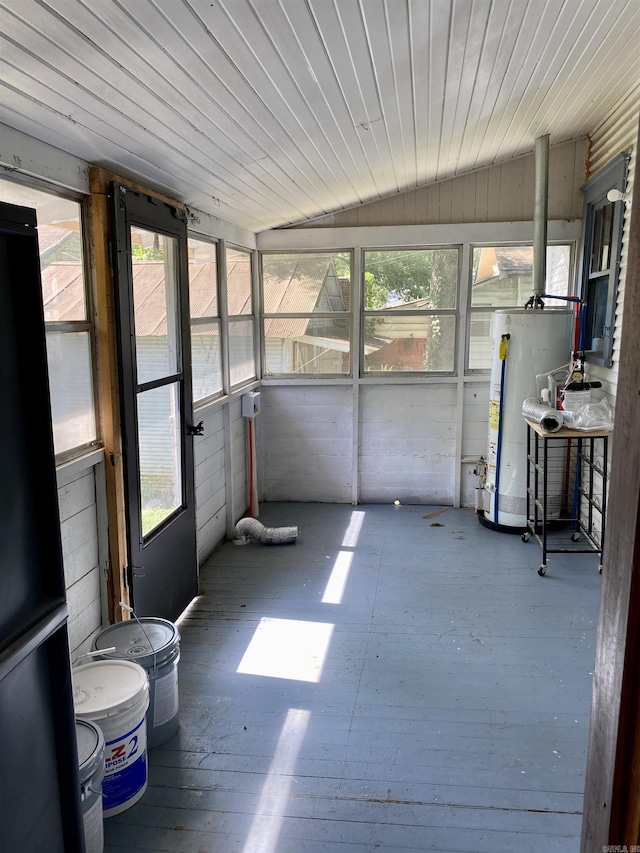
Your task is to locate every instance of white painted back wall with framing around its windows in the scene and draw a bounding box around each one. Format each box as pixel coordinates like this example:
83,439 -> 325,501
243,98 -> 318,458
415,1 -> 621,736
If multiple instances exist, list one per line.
258,220 -> 580,506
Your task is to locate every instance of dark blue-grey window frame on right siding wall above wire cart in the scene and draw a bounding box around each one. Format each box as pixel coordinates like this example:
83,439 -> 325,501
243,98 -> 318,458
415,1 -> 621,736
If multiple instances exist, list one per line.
578,151 -> 631,367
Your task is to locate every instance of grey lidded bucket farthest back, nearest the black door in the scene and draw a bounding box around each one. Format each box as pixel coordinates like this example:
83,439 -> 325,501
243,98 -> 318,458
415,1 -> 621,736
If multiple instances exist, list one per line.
93,616 -> 180,748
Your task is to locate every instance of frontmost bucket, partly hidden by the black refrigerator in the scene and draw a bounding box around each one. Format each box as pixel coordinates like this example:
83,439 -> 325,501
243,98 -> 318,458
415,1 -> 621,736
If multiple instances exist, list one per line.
76,719 -> 104,853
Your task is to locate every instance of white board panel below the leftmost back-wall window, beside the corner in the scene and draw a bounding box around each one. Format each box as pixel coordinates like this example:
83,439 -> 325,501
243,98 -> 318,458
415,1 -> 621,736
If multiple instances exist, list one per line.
258,385 -> 353,503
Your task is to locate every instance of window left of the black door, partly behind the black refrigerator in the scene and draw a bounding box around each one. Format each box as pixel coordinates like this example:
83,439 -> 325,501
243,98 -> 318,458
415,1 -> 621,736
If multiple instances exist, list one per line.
0,171 -> 97,458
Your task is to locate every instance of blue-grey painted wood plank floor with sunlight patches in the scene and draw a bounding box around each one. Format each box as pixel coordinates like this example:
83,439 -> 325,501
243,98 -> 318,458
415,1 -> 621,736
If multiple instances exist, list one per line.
105,504 -> 600,853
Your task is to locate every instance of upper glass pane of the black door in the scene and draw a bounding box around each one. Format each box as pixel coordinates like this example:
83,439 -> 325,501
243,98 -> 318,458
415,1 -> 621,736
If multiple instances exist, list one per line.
131,228 -> 179,385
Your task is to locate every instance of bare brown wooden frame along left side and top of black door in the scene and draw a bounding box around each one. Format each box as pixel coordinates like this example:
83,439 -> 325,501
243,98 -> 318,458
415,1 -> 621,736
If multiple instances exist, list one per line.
86,167 -> 186,623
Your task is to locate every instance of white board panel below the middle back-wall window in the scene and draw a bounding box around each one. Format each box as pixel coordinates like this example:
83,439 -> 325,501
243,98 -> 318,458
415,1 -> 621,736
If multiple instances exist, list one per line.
359,385 -> 457,506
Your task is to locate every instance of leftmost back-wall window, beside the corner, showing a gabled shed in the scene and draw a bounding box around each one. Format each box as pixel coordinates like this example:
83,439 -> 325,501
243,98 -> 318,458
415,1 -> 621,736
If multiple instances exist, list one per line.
262,252 -> 351,376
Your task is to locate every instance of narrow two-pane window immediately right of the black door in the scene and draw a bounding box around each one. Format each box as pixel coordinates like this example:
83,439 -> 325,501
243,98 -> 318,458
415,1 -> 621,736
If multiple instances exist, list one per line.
189,237 -> 222,404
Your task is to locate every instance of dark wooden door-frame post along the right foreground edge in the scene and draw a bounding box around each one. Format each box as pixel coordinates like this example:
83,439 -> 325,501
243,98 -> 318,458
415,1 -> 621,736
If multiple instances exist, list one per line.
581,116 -> 640,853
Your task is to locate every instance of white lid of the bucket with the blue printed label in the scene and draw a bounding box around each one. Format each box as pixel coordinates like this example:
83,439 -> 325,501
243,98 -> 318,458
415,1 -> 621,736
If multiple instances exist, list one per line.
71,660 -> 149,720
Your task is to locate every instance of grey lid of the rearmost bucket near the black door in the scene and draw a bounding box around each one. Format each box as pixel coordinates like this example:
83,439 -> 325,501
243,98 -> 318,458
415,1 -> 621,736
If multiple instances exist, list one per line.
93,616 -> 180,668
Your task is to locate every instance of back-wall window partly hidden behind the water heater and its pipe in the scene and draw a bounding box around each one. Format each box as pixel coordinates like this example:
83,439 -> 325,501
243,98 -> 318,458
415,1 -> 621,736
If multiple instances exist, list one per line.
467,245 -> 571,370
